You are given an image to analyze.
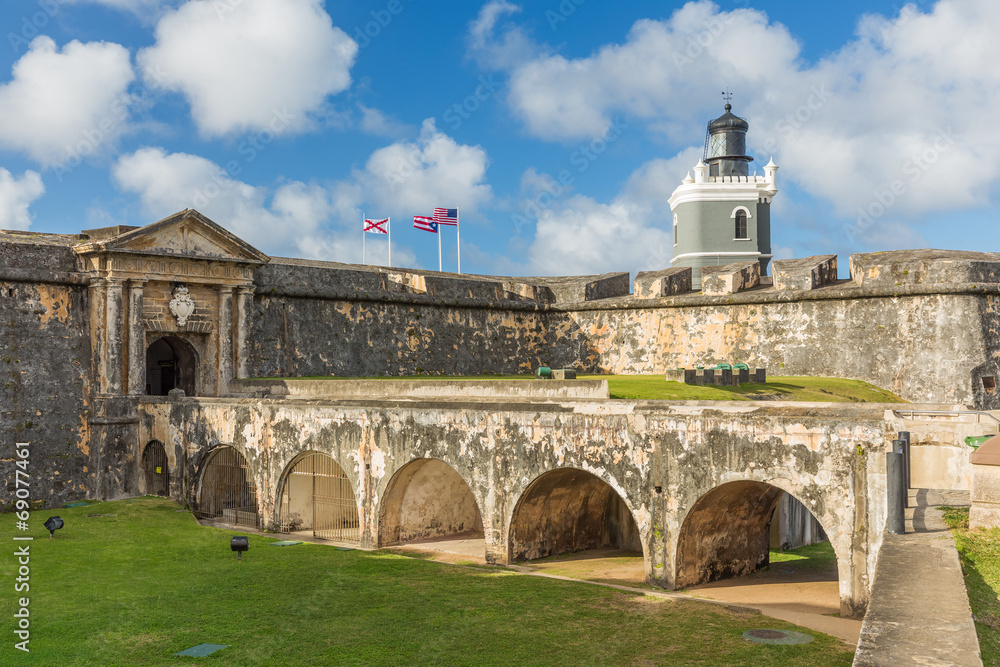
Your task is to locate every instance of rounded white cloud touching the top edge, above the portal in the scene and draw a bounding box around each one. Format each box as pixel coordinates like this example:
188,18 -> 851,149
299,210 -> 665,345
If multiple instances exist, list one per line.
138,0 -> 358,136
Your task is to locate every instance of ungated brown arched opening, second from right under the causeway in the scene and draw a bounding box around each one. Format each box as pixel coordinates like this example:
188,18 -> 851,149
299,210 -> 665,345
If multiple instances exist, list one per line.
509,468 -> 645,582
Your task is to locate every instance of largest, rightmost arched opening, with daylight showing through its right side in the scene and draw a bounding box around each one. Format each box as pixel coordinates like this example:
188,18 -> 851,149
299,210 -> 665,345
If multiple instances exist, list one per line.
674,481 -> 844,628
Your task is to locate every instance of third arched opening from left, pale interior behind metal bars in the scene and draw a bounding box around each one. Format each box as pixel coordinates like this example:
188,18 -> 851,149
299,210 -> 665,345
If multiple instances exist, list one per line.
278,452 -> 361,544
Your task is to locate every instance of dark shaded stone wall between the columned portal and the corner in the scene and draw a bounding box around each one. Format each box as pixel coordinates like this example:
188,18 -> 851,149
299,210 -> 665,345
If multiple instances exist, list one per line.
245,292 -> 552,377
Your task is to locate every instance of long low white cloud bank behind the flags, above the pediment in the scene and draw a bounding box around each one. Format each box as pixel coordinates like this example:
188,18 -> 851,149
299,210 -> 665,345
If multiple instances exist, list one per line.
113,119 -> 492,266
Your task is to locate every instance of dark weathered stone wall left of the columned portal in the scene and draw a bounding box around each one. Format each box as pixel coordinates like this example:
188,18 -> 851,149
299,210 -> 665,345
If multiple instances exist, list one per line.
0,241 -> 95,508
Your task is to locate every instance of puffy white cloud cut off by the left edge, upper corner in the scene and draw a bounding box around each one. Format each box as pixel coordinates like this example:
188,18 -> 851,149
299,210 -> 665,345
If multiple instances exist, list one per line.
0,36 -> 134,166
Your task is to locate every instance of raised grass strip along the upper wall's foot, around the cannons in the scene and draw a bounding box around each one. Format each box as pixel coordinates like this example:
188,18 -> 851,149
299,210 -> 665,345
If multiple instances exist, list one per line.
256,375 -> 905,403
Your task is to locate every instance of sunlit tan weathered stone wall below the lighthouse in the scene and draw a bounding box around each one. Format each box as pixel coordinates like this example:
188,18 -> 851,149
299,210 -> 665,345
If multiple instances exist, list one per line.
552,288 -> 1000,409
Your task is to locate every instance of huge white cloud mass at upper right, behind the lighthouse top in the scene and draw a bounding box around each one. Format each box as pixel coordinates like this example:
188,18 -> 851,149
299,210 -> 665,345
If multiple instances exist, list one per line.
469,0 -> 1000,222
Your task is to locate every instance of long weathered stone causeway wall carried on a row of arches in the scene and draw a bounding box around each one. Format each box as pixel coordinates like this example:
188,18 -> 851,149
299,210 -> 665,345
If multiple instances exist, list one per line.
134,398 -> 898,614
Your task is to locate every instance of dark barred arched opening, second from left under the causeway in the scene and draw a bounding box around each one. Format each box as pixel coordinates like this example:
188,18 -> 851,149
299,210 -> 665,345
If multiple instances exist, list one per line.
197,445 -> 260,528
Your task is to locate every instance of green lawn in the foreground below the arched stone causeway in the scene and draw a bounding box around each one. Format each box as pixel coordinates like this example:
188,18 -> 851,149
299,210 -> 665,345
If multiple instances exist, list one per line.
0,498 -> 852,667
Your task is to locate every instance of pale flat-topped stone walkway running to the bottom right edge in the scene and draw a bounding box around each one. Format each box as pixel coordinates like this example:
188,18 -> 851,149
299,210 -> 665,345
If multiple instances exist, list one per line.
854,489 -> 983,667
